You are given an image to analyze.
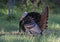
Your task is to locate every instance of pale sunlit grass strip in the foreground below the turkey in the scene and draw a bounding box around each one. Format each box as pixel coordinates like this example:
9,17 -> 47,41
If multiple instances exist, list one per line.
0,33 -> 60,42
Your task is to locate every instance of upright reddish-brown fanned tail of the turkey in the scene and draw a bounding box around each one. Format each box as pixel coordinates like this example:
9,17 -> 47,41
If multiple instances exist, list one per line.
40,6 -> 48,31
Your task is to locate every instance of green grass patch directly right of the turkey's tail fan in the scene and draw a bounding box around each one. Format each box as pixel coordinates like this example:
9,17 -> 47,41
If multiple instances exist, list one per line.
48,14 -> 60,30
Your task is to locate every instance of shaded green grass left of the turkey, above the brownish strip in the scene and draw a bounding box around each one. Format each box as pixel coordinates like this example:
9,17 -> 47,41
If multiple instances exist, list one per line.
0,9 -> 22,32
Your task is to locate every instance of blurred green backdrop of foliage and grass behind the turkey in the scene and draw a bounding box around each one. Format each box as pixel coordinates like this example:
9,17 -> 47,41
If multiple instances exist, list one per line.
0,0 -> 60,32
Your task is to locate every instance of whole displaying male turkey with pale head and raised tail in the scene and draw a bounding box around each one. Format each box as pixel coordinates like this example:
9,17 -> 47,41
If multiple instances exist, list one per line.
19,6 -> 48,34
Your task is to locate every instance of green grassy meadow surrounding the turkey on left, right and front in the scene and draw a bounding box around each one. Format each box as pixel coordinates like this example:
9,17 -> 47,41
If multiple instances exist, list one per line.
0,6 -> 60,42
